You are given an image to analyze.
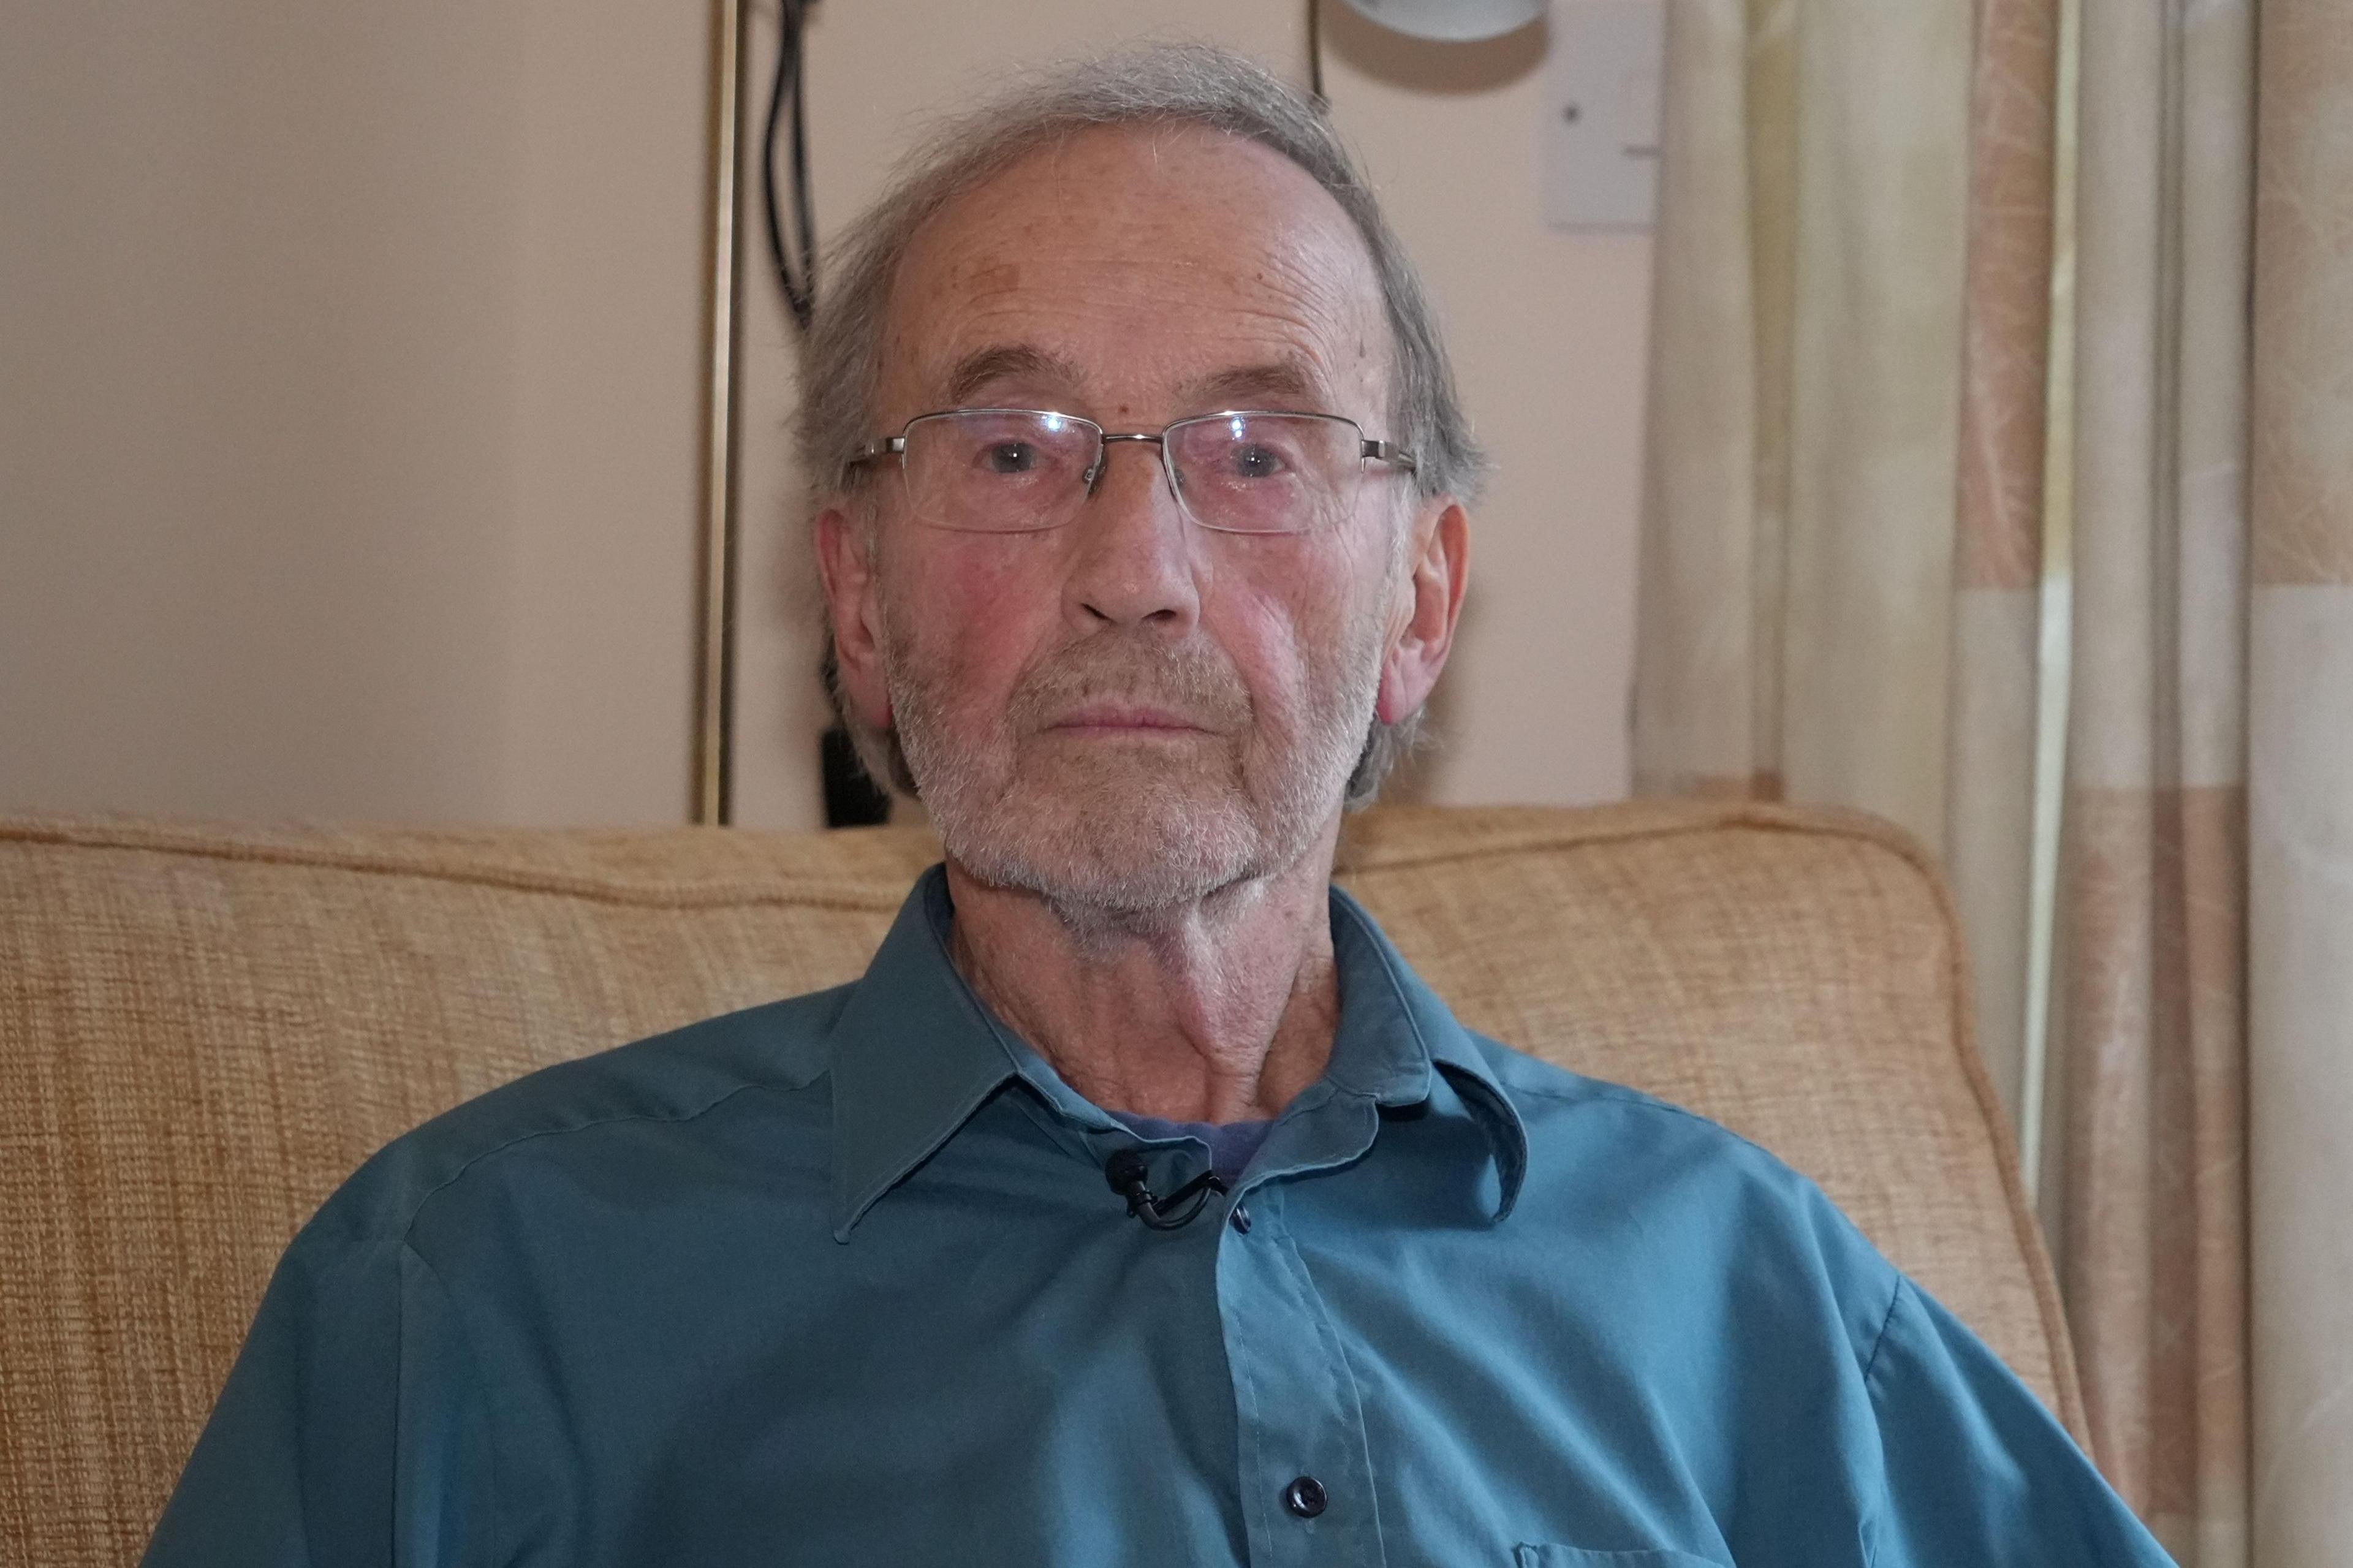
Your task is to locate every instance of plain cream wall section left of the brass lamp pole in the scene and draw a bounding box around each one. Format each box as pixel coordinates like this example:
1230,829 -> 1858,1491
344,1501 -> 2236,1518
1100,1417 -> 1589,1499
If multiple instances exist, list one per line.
0,0 -> 711,822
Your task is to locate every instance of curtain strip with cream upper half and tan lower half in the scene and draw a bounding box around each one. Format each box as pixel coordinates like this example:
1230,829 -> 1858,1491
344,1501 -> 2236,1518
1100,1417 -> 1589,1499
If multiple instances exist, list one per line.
2045,0 -> 2254,1568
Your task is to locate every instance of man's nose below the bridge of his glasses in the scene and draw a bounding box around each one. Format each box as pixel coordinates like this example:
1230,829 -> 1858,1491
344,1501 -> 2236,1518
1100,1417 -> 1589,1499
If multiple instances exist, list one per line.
1064,441 -> 1200,634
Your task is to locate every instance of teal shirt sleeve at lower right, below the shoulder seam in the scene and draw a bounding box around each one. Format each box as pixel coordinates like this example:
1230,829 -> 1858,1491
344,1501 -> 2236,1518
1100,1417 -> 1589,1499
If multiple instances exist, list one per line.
1863,1278 -> 2172,1568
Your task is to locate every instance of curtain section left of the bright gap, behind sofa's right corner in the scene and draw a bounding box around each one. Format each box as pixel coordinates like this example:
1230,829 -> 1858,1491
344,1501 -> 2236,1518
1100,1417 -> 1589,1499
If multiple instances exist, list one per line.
1633,0 -> 2054,1172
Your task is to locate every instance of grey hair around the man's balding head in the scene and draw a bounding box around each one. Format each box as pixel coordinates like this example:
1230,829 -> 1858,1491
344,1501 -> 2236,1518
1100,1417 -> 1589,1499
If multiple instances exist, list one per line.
795,45 -> 1487,810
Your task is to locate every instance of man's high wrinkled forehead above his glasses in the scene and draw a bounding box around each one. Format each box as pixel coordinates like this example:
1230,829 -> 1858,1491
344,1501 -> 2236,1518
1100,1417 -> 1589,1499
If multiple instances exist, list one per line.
875,125 -> 1393,433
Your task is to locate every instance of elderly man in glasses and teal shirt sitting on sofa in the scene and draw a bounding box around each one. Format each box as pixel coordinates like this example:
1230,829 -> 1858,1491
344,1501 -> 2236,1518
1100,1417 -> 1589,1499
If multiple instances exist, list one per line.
148,50 -> 2162,1568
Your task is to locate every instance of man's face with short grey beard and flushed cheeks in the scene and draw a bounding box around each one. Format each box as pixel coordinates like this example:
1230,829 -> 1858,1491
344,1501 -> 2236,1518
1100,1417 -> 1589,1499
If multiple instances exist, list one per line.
821,127 -> 1459,916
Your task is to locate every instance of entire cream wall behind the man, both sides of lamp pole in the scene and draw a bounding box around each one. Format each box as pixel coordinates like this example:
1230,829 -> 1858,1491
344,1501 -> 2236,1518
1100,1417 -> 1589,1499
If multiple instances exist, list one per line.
0,0 -> 1647,824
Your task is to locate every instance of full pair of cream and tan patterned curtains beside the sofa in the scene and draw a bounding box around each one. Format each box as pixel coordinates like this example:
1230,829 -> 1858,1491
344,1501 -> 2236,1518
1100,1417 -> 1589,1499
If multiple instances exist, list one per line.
1635,0 -> 2353,1568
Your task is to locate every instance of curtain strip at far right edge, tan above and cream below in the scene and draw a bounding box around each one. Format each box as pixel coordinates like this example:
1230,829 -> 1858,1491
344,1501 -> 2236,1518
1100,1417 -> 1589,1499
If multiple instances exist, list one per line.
2247,0 -> 2353,1568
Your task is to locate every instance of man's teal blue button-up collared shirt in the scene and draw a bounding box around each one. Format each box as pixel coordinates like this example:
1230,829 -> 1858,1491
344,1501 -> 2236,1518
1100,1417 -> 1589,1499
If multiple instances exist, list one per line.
146,871 -> 2165,1568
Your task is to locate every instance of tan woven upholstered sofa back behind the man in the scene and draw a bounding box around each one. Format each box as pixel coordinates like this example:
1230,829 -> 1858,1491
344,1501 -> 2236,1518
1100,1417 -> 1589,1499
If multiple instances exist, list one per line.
0,803 -> 2082,1568
